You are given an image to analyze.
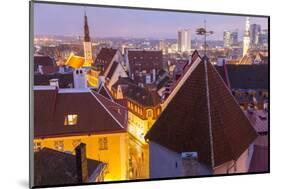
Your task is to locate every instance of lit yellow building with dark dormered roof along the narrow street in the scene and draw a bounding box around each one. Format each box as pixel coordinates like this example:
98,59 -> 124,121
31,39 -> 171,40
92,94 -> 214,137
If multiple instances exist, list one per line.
111,78 -> 162,144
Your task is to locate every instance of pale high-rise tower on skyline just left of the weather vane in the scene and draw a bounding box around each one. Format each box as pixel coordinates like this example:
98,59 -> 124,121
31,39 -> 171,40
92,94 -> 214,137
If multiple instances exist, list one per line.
178,29 -> 191,52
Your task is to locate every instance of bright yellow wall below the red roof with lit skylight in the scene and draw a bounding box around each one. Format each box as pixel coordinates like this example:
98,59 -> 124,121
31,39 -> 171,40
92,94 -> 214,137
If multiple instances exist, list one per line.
33,133 -> 129,181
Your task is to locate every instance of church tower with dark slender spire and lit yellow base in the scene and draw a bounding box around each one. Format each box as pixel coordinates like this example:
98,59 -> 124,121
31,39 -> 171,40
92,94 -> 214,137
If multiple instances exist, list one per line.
83,12 -> 93,67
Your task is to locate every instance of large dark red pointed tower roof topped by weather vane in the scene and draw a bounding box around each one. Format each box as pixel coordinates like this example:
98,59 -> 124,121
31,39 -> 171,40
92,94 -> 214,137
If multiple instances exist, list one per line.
145,51 -> 257,168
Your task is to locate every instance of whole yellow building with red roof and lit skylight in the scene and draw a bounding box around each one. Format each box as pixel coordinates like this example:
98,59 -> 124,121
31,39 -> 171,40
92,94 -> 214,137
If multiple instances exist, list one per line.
34,86 -> 128,181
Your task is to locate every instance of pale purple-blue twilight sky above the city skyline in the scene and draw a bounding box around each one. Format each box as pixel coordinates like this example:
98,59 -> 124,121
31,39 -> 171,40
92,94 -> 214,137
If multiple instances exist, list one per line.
34,3 -> 267,40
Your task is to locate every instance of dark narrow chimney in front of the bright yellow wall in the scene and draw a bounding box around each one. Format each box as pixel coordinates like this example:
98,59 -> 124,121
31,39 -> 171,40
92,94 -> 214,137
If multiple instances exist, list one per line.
75,143 -> 88,183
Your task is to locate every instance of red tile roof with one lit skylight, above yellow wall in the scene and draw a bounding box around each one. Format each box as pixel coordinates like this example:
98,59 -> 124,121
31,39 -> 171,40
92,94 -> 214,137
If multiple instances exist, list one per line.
34,89 -> 127,138
